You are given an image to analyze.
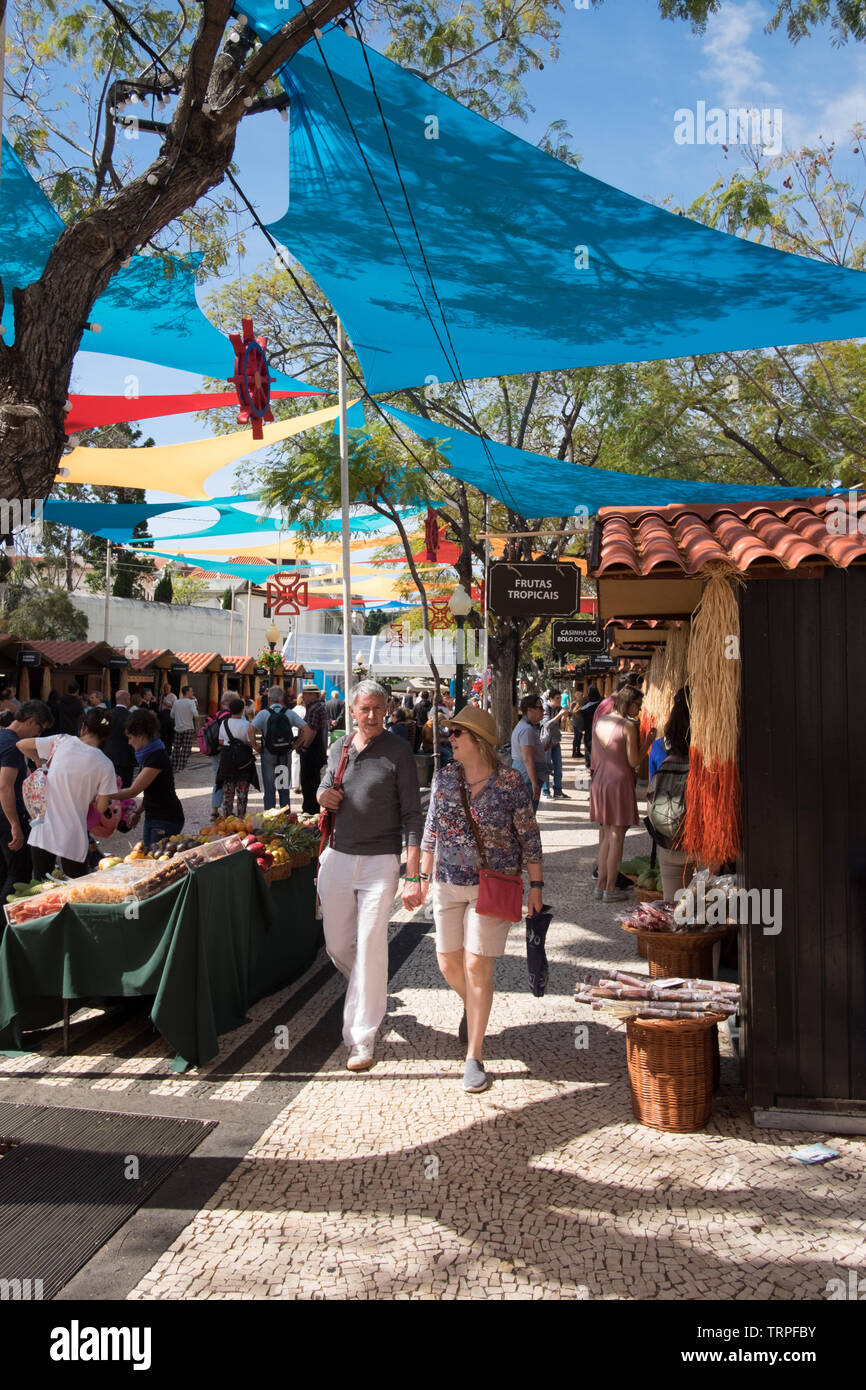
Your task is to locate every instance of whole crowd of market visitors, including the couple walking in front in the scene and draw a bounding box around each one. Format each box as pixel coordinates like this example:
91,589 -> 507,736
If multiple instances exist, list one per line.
0,673 -> 694,1094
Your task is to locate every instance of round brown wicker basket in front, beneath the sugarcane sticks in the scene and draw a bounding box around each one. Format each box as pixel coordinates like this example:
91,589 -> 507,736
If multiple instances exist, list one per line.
626,1013 -> 723,1134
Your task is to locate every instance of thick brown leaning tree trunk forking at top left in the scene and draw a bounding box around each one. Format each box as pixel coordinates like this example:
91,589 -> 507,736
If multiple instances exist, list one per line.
0,0 -> 345,502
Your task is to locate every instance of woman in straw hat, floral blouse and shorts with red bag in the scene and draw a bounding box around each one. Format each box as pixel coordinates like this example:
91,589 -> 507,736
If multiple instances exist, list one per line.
421,706 -> 544,1094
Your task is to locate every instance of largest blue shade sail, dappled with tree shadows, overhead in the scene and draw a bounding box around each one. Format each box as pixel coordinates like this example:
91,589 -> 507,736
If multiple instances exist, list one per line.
243,24 -> 866,393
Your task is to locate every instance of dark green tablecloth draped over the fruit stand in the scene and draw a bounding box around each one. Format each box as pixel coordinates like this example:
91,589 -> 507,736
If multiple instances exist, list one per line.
0,853 -> 321,1070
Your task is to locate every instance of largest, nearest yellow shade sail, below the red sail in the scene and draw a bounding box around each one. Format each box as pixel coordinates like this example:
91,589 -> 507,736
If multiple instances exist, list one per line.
58,402 -> 348,500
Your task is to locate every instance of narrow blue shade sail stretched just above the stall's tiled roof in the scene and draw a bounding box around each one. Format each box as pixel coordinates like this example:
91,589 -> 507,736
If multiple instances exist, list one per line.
384,406 -> 844,517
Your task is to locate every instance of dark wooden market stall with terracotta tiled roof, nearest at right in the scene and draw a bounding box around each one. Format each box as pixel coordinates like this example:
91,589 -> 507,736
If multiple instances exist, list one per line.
589,499 -> 866,1133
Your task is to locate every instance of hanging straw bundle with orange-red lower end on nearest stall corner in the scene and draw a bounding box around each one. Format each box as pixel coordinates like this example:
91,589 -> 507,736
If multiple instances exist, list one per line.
678,566 -> 741,867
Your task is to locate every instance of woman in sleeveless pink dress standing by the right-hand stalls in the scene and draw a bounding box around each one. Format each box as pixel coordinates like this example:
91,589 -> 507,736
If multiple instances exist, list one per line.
589,685 -> 655,902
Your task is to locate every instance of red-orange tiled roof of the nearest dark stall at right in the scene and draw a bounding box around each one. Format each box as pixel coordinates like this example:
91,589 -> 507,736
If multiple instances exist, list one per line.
592,493 -> 866,577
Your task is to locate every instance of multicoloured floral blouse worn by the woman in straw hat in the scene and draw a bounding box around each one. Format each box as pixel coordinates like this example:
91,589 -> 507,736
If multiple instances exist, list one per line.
421,763 -> 541,885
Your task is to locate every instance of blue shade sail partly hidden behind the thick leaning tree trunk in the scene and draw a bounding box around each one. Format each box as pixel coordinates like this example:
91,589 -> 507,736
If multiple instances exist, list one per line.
0,139 -> 318,391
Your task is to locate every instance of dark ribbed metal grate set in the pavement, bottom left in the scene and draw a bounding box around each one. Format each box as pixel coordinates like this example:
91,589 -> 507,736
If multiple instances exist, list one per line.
0,1102 -> 215,1300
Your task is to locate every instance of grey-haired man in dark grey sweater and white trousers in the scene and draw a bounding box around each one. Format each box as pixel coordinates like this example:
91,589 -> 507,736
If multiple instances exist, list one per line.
318,681 -> 424,1072
